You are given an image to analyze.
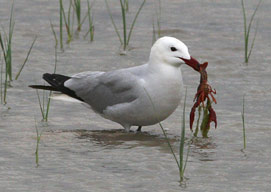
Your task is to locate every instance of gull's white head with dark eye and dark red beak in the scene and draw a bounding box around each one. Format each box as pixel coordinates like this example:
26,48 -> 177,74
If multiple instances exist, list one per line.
149,36 -> 201,69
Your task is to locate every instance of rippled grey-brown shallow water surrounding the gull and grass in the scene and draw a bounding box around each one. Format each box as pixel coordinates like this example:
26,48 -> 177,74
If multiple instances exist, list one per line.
0,0 -> 271,192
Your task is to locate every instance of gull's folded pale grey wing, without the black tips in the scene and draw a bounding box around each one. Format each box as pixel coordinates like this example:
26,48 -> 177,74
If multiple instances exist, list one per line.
65,70 -> 139,113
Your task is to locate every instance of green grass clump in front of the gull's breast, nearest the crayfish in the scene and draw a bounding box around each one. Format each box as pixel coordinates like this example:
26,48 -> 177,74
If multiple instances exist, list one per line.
144,88 -> 192,183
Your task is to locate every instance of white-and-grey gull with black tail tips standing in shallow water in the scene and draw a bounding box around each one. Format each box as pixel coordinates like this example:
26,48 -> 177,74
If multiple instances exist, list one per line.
30,36 -> 199,132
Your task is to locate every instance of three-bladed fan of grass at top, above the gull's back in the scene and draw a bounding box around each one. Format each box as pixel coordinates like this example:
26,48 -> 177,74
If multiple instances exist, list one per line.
105,0 -> 146,51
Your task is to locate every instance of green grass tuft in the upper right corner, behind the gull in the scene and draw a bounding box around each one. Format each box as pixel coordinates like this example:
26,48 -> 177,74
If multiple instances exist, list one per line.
241,0 -> 262,63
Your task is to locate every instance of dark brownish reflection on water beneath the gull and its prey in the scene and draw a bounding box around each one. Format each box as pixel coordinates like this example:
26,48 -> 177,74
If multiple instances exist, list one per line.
74,129 -> 219,161
